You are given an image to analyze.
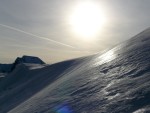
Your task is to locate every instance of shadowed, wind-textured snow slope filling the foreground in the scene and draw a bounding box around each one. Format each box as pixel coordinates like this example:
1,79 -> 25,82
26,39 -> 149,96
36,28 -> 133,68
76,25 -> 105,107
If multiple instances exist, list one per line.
0,29 -> 150,113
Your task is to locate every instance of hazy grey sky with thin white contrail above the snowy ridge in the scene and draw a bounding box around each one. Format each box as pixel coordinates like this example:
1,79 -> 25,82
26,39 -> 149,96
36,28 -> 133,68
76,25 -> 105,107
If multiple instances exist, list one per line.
0,0 -> 150,63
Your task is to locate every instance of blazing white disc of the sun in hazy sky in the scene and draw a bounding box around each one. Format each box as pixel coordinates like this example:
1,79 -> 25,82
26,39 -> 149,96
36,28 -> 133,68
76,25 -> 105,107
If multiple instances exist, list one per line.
70,2 -> 105,39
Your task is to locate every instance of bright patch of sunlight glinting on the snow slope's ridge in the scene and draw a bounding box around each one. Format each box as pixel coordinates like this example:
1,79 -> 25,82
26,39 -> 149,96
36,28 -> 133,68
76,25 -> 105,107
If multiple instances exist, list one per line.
94,50 -> 116,66
